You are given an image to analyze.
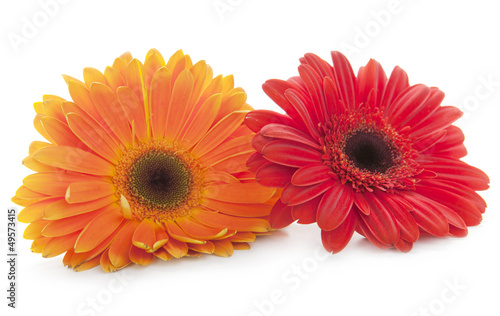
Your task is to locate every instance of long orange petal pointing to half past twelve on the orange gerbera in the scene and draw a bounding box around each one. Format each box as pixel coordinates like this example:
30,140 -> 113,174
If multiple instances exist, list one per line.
165,70 -> 194,141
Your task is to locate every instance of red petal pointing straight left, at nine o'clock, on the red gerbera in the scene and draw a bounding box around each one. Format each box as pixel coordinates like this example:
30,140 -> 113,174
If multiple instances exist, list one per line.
261,140 -> 321,167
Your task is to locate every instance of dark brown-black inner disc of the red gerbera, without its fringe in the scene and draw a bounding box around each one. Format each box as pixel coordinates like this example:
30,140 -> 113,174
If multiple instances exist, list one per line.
344,131 -> 393,173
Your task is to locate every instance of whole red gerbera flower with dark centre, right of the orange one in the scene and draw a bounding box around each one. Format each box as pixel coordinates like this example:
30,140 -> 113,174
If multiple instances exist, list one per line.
245,52 -> 489,252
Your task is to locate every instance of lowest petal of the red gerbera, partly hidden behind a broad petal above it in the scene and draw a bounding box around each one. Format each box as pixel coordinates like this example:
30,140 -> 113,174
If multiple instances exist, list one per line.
321,212 -> 357,253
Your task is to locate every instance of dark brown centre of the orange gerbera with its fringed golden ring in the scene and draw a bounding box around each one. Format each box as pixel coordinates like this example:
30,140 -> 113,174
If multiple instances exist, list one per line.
113,139 -> 204,223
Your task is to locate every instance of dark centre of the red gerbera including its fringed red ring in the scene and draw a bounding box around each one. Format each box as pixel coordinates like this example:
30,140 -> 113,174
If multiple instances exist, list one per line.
322,108 -> 420,191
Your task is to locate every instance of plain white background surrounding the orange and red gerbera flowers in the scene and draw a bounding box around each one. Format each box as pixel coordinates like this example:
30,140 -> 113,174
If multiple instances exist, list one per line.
0,0 -> 500,316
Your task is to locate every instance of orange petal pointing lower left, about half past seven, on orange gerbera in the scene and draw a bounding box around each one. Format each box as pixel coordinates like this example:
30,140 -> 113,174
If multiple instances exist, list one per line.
75,209 -> 124,253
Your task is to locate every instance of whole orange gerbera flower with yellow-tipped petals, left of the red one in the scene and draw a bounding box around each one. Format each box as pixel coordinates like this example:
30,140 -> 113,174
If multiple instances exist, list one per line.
12,49 -> 278,271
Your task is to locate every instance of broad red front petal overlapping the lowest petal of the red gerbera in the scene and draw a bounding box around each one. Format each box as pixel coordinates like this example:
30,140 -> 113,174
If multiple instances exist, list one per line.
316,182 -> 354,230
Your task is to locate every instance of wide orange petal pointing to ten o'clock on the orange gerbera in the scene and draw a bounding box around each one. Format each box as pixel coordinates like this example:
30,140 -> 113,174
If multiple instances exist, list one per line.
67,113 -> 120,163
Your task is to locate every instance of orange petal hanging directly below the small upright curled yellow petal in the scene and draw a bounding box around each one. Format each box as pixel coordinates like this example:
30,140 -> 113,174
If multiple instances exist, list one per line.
108,221 -> 139,268
